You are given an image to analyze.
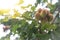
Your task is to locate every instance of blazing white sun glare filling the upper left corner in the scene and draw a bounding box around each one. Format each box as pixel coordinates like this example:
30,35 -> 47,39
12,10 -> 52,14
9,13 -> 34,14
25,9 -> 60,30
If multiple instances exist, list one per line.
0,0 -> 19,9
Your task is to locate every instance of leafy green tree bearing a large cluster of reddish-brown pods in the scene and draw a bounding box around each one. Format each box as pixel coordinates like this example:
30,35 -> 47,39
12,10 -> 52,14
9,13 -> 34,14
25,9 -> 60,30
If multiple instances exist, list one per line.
1,0 -> 57,40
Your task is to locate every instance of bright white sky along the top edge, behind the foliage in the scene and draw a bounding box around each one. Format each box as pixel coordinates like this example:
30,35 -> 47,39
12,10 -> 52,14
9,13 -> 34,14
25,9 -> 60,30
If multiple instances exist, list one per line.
0,0 -> 57,9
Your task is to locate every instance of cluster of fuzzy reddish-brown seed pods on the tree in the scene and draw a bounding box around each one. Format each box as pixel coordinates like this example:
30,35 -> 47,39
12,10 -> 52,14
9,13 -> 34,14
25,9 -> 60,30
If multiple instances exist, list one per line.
35,9 -> 53,22
